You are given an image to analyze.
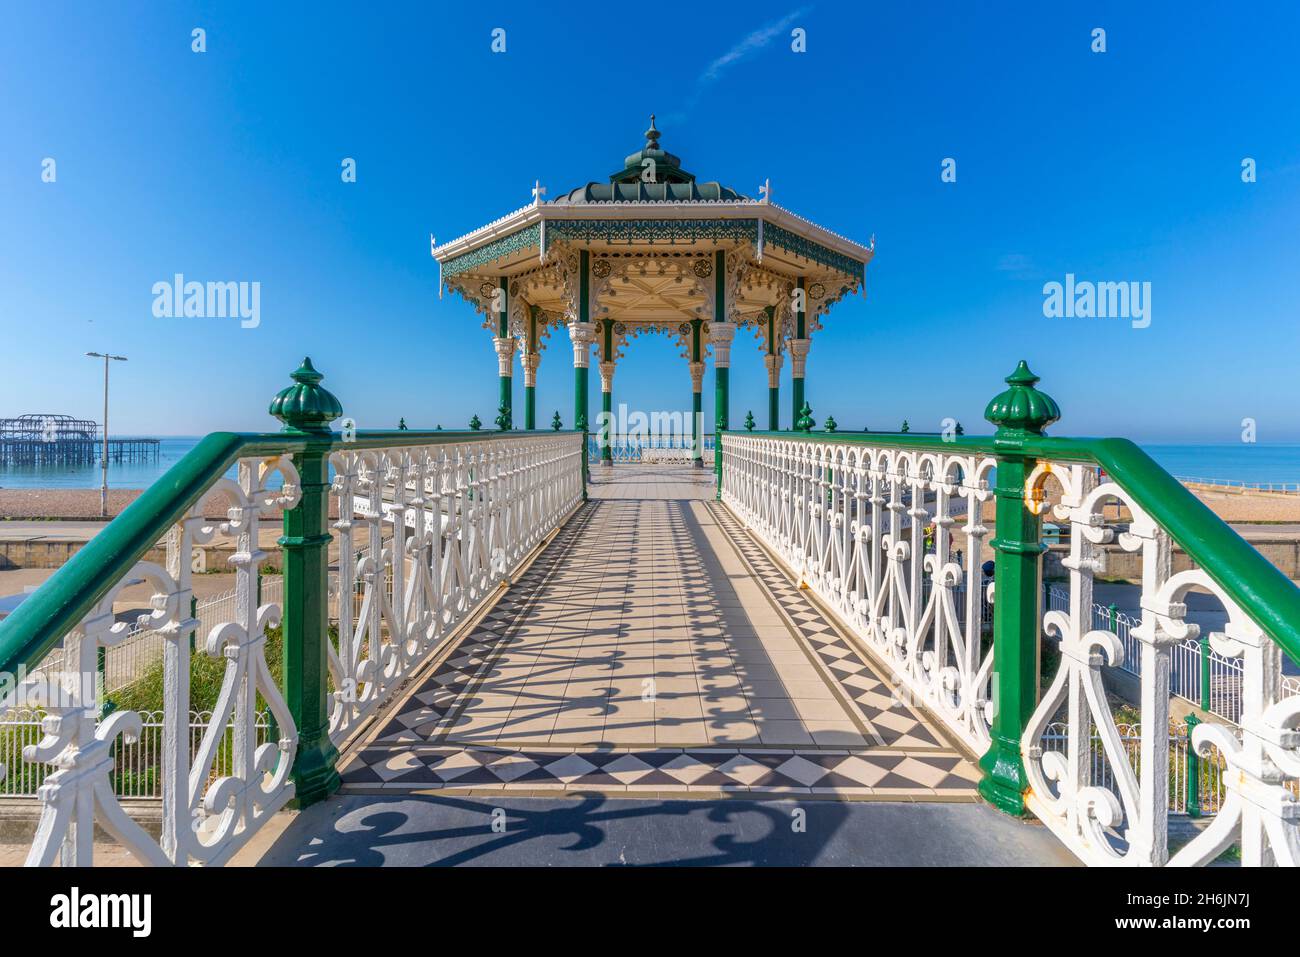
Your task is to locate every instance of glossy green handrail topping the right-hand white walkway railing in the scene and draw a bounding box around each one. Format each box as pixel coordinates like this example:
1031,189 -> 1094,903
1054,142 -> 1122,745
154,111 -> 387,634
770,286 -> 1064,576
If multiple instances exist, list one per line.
725,432 -> 1300,662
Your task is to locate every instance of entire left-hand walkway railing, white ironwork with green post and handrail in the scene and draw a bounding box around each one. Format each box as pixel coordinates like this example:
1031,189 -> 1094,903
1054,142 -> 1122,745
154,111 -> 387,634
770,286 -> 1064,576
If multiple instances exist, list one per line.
0,360 -> 584,865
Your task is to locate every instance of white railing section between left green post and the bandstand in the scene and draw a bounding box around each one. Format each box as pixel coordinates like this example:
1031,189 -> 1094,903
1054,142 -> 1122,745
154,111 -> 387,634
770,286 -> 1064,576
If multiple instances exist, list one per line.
329,433 -> 582,742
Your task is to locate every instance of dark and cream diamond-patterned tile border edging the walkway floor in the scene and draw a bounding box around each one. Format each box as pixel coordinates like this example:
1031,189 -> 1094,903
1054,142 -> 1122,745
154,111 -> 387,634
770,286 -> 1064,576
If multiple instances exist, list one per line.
330,486 -> 979,801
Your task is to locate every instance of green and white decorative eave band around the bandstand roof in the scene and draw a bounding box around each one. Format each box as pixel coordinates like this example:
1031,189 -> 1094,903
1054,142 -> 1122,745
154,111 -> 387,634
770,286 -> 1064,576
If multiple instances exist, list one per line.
433,200 -> 874,281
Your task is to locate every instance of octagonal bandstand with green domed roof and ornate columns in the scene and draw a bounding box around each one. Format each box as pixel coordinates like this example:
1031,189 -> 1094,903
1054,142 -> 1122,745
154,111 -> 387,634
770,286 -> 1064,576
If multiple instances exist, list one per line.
433,116 -> 872,475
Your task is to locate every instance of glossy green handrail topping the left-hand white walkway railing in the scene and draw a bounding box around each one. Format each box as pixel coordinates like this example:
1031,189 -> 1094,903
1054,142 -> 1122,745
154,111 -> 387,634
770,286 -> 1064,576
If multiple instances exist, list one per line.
0,429 -> 576,675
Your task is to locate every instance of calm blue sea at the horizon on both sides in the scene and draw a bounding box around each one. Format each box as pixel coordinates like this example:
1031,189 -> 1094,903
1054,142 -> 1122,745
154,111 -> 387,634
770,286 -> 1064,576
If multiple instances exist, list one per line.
0,436 -> 1300,489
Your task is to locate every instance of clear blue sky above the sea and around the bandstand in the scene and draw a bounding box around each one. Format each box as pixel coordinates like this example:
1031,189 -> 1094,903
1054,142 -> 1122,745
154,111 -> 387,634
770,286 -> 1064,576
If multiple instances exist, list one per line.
0,0 -> 1300,442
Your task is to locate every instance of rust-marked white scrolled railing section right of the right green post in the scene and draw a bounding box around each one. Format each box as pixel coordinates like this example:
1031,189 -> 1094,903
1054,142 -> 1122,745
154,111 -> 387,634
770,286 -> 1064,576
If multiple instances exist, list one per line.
1021,463 -> 1300,866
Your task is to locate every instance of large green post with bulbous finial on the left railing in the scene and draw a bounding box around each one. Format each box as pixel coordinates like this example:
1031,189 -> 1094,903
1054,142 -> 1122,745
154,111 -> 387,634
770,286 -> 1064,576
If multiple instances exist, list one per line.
270,359 -> 343,807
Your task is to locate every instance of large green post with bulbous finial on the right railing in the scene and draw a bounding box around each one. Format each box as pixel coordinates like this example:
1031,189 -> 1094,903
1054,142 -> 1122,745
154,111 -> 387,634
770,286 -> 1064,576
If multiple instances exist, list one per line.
979,360 -> 1061,815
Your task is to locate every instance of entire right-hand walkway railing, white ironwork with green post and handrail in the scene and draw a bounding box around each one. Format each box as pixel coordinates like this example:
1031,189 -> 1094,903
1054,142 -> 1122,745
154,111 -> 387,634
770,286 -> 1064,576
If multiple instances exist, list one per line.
719,363 -> 1300,866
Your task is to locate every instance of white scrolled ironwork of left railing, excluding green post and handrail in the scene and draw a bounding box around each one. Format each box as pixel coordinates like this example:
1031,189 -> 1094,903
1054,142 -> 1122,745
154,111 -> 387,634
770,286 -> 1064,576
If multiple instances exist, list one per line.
0,433 -> 582,866
